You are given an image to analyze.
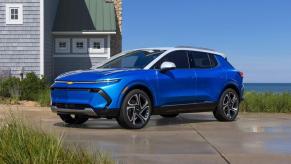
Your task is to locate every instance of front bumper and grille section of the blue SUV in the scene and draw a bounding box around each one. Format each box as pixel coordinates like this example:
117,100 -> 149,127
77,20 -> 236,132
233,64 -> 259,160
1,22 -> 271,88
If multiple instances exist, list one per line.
51,85 -> 119,118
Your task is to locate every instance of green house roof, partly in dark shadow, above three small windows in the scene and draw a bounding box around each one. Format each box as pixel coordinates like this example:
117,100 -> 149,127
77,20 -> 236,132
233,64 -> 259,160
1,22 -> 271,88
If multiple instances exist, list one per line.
53,0 -> 116,32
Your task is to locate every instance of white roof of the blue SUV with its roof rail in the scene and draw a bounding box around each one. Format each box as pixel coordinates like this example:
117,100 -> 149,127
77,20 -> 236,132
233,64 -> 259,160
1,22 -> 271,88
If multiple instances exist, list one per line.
135,46 -> 226,57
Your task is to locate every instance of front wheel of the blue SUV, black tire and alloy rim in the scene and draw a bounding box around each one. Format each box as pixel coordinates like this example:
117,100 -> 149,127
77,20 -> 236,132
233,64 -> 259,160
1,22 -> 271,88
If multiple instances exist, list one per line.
117,89 -> 152,129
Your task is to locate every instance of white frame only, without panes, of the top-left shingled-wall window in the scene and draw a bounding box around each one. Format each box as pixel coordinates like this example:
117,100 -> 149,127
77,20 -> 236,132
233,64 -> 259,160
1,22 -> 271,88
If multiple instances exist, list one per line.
6,4 -> 23,25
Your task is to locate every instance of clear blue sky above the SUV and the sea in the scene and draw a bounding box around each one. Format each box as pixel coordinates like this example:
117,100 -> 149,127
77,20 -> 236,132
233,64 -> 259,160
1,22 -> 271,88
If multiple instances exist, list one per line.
123,0 -> 291,82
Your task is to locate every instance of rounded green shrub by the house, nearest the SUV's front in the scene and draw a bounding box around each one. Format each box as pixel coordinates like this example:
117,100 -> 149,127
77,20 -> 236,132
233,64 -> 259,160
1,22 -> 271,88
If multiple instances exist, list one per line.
21,73 -> 47,101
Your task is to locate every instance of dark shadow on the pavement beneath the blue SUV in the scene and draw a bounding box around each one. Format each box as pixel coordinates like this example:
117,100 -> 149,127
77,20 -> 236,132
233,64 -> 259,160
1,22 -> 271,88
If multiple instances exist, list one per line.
54,114 -> 216,129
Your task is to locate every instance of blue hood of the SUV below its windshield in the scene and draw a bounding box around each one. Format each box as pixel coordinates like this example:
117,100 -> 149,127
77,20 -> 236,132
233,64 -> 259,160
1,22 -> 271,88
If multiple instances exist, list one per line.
56,69 -> 132,82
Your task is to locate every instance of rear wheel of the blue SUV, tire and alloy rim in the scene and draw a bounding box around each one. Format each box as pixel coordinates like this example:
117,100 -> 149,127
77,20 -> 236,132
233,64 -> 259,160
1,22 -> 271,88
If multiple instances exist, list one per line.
213,88 -> 240,122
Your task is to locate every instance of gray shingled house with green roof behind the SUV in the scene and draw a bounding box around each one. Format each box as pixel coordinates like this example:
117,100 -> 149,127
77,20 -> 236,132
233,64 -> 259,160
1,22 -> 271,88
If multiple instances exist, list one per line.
0,0 -> 122,80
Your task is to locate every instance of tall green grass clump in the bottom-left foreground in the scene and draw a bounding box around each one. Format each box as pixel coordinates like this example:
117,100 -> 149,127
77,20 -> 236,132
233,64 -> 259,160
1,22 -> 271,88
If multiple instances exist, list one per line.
0,118 -> 113,164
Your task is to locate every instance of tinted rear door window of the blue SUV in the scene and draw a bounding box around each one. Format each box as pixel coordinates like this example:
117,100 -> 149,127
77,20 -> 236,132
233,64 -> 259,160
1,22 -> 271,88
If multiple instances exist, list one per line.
189,51 -> 212,68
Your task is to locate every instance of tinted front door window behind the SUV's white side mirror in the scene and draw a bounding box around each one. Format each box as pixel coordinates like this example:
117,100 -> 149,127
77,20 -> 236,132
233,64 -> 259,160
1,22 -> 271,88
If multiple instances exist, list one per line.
153,51 -> 189,69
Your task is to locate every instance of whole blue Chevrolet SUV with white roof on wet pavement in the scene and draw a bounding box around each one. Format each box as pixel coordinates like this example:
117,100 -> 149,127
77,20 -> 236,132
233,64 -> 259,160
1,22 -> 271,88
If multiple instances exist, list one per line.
51,47 -> 243,129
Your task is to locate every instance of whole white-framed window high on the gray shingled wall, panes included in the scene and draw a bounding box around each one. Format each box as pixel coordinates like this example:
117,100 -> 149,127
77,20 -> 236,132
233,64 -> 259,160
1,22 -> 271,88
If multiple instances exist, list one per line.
6,4 -> 23,24
